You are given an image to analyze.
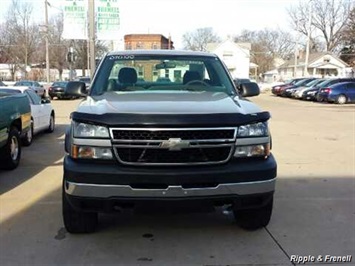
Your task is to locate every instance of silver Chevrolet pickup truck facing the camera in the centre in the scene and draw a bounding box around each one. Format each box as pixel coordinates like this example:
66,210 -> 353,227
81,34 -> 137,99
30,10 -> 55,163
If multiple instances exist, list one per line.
62,50 -> 277,233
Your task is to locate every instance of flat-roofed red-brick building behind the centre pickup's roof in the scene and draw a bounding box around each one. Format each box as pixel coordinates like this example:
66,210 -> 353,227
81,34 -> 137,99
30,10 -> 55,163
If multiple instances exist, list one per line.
124,34 -> 174,50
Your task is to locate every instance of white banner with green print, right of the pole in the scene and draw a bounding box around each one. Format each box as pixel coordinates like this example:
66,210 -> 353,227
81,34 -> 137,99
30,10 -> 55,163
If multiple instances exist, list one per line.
95,0 -> 120,40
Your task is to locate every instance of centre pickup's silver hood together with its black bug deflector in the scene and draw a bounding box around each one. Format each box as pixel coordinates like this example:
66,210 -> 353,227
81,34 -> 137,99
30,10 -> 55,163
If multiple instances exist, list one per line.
72,92 -> 270,127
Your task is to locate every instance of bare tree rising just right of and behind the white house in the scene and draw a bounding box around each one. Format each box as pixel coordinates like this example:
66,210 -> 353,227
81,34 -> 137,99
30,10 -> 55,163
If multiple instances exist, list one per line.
234,29 -> 295,73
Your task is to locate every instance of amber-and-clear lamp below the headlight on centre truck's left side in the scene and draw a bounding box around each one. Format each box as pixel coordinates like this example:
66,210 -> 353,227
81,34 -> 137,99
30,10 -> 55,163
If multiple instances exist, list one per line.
71,145 -> 113,160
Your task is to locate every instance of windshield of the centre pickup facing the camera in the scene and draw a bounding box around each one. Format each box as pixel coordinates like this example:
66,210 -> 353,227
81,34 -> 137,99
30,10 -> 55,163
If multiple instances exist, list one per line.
91,55 -> 236,95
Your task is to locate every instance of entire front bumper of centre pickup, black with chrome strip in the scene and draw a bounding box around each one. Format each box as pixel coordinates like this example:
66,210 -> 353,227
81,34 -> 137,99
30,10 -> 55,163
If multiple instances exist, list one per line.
64,155 -> 277,212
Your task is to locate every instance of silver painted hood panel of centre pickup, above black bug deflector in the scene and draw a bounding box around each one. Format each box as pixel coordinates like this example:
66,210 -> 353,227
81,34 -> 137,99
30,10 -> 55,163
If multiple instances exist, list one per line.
77,91 -> 261,115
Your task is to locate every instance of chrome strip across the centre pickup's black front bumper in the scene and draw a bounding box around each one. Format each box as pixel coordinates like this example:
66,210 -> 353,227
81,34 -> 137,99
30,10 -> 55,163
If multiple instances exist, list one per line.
65,178 -> 276,198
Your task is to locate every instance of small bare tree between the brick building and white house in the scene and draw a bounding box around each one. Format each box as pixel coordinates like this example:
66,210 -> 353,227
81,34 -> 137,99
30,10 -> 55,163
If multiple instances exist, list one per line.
182,28 -> 221,51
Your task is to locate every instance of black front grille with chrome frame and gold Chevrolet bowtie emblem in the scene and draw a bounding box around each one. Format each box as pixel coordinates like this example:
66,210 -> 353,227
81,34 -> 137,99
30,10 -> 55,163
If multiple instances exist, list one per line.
110,128 -> 236,165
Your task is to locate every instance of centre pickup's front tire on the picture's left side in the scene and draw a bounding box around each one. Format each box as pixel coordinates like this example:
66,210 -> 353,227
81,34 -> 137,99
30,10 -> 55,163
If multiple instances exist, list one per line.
62,181 -> 98,234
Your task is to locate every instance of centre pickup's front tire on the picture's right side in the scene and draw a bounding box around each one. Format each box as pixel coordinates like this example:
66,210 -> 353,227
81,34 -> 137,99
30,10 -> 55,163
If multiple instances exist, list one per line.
233,196 -> 273,230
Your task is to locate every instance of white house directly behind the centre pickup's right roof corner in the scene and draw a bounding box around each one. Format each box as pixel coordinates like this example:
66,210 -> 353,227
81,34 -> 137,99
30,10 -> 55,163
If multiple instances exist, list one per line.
206,39 -> 253,78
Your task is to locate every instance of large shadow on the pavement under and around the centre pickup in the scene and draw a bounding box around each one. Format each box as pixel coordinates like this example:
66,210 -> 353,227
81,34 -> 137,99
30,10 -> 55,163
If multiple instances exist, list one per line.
0,176 -> 355,265
